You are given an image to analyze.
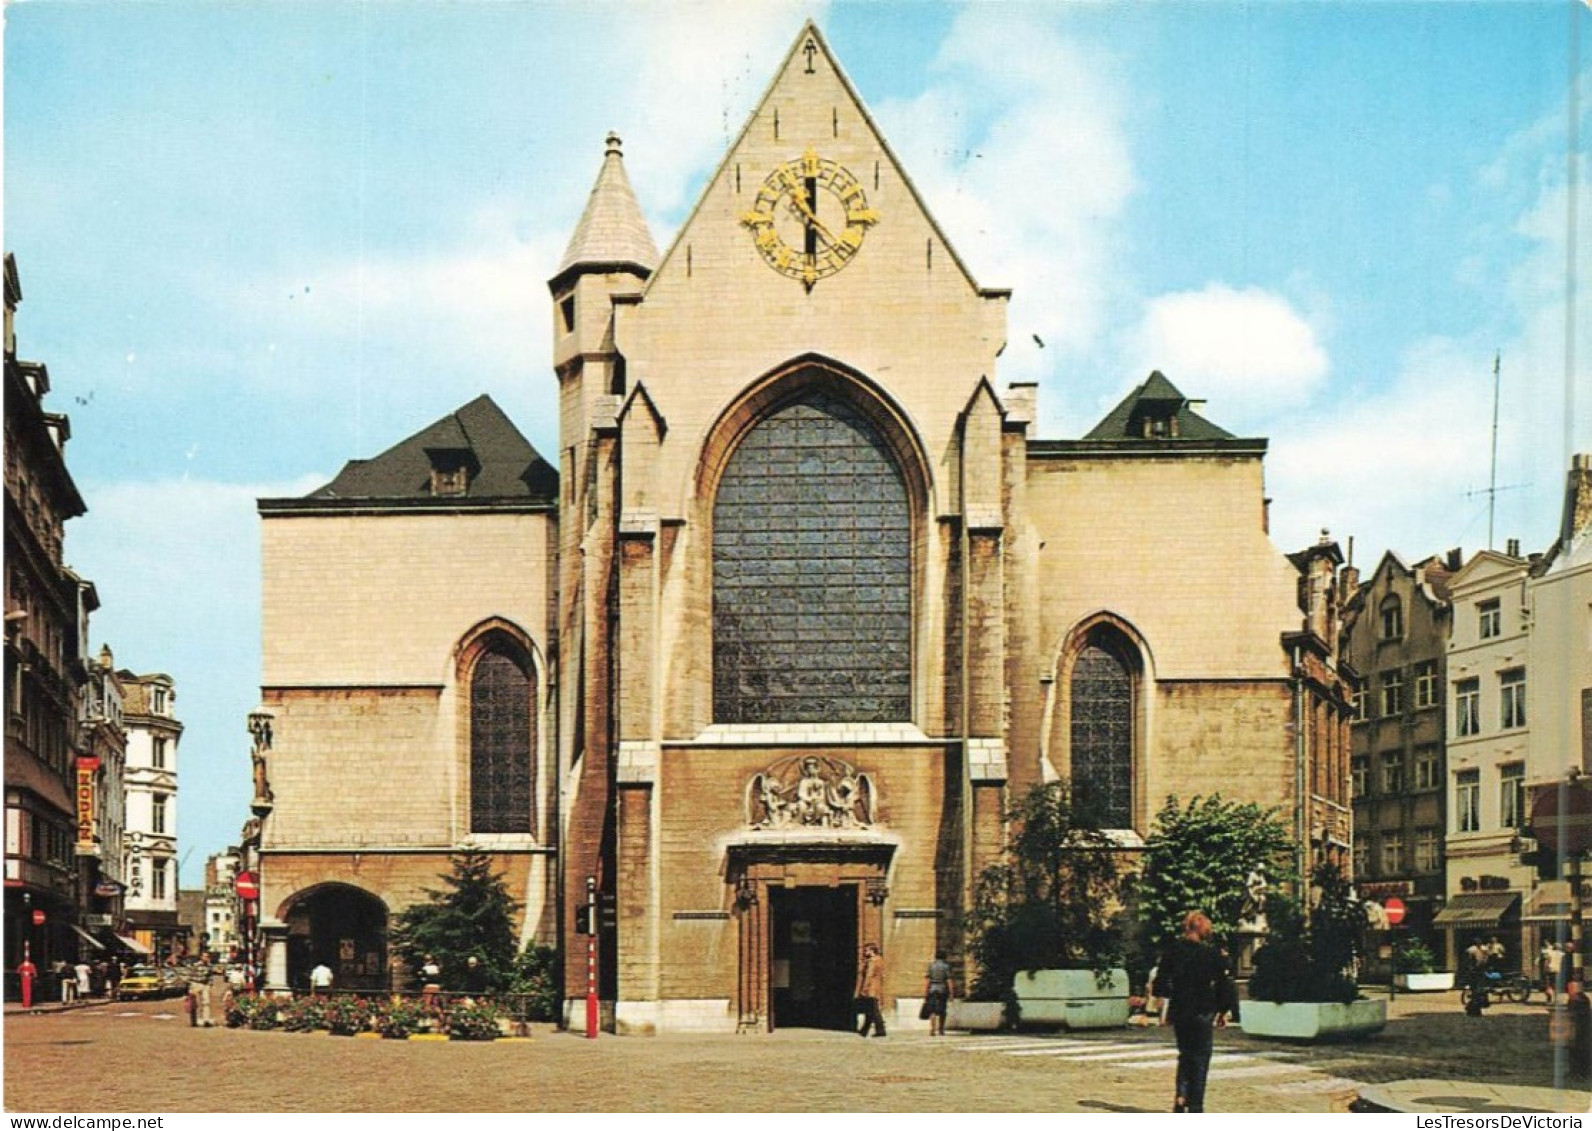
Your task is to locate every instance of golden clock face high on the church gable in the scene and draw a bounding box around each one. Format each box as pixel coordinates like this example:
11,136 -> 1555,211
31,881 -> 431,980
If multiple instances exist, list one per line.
740,150 -> 879,290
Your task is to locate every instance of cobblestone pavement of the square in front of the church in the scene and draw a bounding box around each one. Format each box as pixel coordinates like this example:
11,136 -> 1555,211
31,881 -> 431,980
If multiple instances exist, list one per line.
5,994 -> 1586,1113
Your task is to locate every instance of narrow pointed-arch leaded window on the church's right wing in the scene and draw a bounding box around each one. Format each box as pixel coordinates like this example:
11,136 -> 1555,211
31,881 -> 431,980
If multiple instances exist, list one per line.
1071,644 -> 1134,828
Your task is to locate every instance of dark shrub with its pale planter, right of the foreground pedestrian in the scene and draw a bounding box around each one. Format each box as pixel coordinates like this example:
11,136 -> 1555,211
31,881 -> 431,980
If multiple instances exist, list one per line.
1242,863 -> 1387,1040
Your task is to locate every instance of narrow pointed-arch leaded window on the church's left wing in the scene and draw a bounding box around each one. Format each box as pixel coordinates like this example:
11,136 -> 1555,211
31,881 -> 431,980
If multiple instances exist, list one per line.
470,652 -> 537,833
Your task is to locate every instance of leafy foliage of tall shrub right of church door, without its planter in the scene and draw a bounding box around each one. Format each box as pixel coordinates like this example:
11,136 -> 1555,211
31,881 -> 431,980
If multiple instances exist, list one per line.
970,781 -> 1122,1000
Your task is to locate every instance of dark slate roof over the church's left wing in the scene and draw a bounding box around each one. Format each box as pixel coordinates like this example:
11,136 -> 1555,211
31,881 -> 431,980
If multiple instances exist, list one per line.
306,393 -> 559,503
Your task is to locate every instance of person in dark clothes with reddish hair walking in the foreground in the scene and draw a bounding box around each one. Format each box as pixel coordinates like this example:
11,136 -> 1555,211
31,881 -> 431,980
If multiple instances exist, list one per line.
1154,911 -> 1235,1112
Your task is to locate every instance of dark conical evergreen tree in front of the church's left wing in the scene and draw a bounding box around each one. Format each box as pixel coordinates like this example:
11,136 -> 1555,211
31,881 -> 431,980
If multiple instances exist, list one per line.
393,844 -> 519,989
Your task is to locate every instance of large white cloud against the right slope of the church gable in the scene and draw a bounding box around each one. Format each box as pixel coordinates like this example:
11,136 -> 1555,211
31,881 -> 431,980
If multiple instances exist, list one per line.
876,5 -> 1137,379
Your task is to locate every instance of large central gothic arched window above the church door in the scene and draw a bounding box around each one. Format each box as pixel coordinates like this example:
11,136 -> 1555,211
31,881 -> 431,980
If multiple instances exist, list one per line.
713,390 -> 912,723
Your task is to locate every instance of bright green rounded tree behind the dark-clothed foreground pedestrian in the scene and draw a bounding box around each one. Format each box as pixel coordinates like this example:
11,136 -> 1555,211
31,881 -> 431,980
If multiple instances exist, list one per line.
1137,793 -> 1293,954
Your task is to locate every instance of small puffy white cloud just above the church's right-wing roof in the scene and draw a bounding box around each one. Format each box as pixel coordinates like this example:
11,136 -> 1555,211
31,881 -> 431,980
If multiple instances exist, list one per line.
1130,284 -> 1331,424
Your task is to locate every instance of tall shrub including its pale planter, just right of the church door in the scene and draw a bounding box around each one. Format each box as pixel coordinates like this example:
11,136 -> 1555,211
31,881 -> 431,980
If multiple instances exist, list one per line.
947,781 -> 1129,1029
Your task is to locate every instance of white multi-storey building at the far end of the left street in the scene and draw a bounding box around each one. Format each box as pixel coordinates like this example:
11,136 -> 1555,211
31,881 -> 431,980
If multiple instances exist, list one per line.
119,671 -> 188,961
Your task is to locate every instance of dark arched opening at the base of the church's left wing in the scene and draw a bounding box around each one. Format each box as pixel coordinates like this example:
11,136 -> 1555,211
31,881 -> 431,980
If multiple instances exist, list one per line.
282,884 -> 392,989
